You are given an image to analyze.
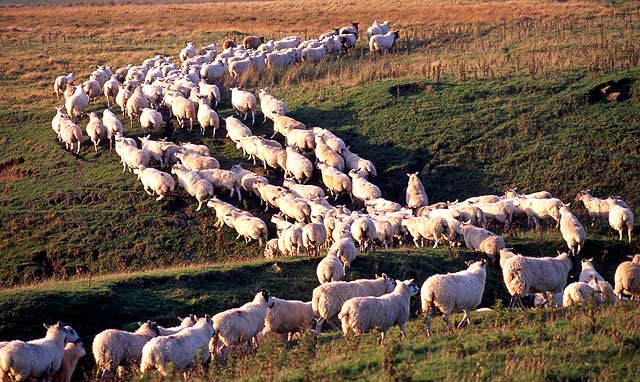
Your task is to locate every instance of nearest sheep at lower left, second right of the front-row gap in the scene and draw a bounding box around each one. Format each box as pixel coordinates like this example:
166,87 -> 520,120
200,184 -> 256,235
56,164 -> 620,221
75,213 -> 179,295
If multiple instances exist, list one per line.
140,314 -> 215,376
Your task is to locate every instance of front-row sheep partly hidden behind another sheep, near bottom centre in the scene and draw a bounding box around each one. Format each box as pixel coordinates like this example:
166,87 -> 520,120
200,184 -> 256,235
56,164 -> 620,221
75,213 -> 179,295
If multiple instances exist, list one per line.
311,273 -> 395,333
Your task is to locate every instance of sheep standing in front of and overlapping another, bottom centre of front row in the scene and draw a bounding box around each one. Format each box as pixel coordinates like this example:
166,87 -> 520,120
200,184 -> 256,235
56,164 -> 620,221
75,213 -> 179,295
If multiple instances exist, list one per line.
338,279 -> 420,343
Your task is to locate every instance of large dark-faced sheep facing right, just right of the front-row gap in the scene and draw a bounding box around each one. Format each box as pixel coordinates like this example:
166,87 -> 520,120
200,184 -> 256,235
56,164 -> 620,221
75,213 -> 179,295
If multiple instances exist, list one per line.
500,253 -> 580,310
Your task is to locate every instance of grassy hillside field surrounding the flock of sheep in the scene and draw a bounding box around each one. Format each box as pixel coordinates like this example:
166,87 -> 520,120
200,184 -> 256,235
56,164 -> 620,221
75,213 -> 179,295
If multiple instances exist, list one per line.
0,0 -> 640,381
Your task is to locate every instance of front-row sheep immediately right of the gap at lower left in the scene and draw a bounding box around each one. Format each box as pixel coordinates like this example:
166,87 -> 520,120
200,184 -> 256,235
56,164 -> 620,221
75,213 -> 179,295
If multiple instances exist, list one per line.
92,321 -> 160,379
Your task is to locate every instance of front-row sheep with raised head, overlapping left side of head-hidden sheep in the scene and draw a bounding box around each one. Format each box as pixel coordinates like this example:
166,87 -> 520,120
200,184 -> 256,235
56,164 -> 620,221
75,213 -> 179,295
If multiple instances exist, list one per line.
211,290 -> 274,360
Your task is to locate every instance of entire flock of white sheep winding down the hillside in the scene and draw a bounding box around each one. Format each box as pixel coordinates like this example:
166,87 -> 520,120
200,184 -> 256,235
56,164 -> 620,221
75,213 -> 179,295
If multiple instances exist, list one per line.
0,22 -> 640,381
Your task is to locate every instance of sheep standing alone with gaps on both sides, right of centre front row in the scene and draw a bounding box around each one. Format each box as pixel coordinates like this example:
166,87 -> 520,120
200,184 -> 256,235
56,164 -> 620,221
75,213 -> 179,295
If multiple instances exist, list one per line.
420,260 -> 487,336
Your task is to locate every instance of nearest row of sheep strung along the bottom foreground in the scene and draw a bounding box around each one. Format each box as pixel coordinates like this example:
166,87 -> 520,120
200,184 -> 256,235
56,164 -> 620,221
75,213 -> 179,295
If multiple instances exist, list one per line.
5,250 -> 640,382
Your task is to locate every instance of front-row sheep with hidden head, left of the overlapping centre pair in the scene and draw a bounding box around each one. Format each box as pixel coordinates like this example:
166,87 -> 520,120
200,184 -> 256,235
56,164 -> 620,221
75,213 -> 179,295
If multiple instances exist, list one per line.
262,297 -> 313,341
